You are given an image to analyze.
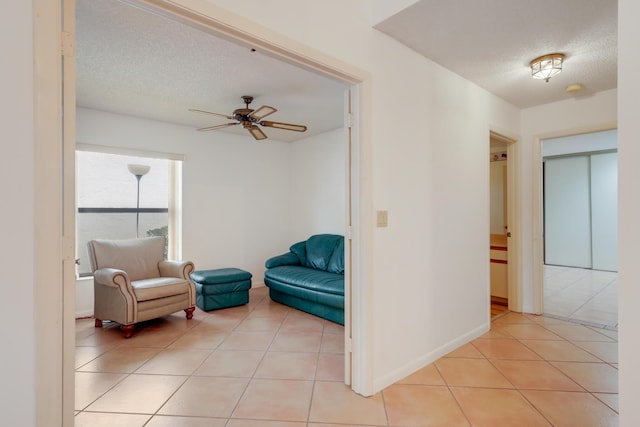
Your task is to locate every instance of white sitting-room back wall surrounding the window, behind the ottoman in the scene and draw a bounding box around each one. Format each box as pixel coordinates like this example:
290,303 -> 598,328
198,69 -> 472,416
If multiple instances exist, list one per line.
77,108 -> 291,285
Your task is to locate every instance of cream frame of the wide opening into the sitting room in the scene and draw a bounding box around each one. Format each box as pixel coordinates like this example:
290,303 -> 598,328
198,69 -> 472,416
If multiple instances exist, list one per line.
43,0 -> 373,425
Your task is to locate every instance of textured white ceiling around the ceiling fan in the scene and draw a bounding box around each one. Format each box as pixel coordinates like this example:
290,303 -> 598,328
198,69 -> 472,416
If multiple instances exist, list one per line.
76,0 -> 345,141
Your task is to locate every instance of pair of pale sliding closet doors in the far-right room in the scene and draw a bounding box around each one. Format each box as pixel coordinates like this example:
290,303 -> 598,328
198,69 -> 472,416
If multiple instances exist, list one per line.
544,152 -> 618,271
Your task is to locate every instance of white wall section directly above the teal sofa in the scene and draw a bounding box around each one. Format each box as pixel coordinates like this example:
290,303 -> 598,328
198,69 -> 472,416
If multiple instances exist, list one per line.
285,129 -> 347,242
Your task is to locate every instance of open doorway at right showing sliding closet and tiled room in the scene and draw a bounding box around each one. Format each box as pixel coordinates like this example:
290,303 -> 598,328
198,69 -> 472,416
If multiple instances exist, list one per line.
541,130 -> 618,329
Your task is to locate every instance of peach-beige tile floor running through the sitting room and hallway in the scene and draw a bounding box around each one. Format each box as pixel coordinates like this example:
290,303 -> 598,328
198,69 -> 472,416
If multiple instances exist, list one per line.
75,288 -> 618,427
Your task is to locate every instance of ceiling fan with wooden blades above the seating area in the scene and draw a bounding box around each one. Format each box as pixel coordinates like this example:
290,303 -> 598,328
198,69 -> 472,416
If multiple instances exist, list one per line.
189,95 -> 307,140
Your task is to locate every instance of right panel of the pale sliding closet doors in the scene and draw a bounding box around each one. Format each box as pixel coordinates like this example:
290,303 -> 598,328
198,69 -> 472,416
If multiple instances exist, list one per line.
591,153 -> 618,271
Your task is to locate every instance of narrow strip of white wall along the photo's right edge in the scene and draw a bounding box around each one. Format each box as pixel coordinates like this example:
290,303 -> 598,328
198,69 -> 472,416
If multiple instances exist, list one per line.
618,0 -> 640,427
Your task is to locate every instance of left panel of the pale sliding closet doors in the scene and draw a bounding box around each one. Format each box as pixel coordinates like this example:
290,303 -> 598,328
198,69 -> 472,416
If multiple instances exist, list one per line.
544,156 -> 591,268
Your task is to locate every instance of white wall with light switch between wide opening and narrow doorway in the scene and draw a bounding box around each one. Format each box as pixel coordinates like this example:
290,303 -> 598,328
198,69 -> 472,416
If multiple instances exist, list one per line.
200,0 -> 520,390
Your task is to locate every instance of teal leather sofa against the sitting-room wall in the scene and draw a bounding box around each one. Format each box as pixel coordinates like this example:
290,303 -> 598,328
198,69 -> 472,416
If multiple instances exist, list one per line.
264,234 -> 344,325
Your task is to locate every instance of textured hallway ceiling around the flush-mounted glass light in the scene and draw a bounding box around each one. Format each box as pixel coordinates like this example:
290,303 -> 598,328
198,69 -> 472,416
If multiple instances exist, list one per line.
376,0 -> 618,108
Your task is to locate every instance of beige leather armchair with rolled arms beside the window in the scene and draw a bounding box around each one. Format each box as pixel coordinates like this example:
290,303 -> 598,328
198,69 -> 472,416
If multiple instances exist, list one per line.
87,237 -> 196,338
